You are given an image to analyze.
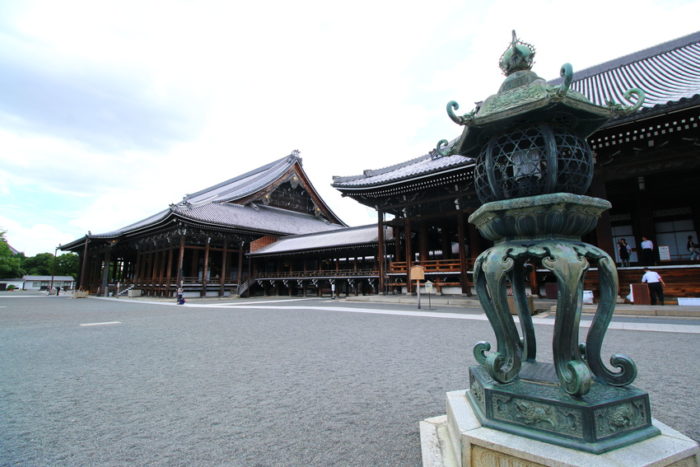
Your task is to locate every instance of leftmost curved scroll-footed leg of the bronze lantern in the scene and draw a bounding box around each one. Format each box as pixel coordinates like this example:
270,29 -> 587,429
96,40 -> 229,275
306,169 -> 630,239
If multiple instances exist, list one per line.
474,245 -> 521,383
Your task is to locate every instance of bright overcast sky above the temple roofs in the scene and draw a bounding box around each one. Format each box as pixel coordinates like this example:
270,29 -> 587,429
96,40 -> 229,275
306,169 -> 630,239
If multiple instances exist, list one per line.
0,0 -> 700,256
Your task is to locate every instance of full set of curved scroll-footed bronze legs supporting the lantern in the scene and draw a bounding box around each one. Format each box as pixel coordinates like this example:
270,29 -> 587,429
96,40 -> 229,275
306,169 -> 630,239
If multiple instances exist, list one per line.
474,240 -> 637,397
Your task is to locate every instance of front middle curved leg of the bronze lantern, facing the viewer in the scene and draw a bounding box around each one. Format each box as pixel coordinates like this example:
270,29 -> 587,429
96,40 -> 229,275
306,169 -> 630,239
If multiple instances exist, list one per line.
542,241 -> 593,396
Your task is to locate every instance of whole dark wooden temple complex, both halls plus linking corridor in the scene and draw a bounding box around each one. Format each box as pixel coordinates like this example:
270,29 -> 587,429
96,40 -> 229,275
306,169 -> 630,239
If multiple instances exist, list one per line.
61,32 -> 700,296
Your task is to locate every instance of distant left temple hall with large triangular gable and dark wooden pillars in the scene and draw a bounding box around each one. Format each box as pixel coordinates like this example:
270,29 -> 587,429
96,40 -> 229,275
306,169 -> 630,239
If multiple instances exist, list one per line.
61,155 -> 346,296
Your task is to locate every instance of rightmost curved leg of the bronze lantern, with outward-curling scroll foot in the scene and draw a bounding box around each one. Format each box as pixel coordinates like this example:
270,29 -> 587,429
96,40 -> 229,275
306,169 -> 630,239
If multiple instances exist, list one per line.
586,245 -> 637,386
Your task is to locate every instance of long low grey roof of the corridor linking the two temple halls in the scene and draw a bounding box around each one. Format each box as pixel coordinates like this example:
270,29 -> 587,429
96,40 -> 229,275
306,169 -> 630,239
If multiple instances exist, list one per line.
250,225 -> 393,256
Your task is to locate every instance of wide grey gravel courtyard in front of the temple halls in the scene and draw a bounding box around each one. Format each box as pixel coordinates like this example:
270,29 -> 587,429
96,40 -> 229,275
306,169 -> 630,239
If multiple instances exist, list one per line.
0,295 -> 700,466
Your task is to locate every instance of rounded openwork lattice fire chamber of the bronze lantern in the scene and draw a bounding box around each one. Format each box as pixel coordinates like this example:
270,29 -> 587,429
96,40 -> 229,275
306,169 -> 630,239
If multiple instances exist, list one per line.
474,123 -> 593,203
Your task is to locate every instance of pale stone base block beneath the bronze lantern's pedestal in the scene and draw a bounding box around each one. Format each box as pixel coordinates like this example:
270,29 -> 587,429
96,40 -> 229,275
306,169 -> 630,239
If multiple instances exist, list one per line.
420,390 -> 700,467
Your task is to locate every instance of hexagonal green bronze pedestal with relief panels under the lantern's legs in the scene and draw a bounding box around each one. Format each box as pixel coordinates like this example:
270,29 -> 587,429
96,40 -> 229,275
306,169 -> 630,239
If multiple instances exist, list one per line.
468,363 -> 659,454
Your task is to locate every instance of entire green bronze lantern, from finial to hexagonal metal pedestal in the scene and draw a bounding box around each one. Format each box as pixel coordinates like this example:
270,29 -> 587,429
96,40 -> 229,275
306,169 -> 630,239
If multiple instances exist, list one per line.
436,32 -> 658,453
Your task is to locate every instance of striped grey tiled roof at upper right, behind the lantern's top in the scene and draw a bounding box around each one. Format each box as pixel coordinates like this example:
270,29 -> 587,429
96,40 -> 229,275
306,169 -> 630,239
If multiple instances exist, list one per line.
550,32 -> 700,108
